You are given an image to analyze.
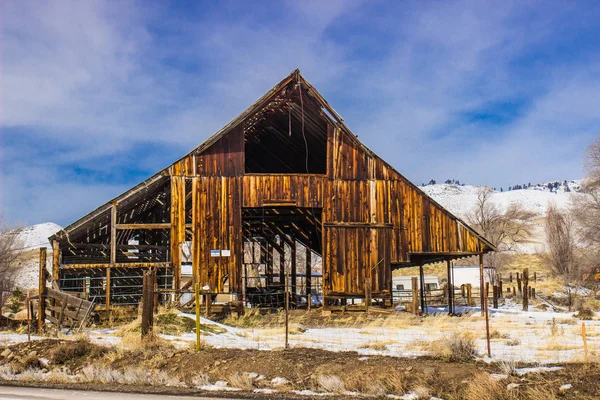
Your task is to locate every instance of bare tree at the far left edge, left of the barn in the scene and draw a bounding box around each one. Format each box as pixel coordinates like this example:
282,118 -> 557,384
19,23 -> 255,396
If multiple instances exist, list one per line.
0,217 -> 22,308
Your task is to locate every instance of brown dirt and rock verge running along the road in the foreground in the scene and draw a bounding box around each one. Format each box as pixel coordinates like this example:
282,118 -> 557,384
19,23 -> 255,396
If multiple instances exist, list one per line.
0,339 -> 600,400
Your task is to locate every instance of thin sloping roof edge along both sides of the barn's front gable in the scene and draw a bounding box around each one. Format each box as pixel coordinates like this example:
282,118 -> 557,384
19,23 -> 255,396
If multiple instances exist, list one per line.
49,69 -> 496,251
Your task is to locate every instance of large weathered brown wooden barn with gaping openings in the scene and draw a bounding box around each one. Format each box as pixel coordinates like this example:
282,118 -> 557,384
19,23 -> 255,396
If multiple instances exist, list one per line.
50,70 -> 494,308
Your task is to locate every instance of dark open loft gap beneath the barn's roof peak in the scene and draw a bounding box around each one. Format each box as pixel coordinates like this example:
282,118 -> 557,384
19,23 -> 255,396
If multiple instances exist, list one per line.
244,85 -> 328,174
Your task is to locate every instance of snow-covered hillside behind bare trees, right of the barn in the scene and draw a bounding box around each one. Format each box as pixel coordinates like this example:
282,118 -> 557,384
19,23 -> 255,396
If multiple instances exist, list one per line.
421,181 -> 580,253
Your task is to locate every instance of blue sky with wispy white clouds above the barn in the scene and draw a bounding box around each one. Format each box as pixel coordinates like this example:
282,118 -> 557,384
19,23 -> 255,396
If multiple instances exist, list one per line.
0,0 -> 600,225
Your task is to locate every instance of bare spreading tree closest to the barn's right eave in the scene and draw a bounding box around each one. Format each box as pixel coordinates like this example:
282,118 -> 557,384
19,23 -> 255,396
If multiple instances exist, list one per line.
467,188 -> 535,281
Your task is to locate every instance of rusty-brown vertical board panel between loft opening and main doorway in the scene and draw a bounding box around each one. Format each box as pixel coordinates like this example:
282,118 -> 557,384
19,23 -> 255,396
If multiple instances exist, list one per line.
242,174 -> 326,208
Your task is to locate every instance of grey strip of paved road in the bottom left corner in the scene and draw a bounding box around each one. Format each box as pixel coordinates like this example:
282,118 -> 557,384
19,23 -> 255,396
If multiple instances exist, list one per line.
0,386 -> 243,400
